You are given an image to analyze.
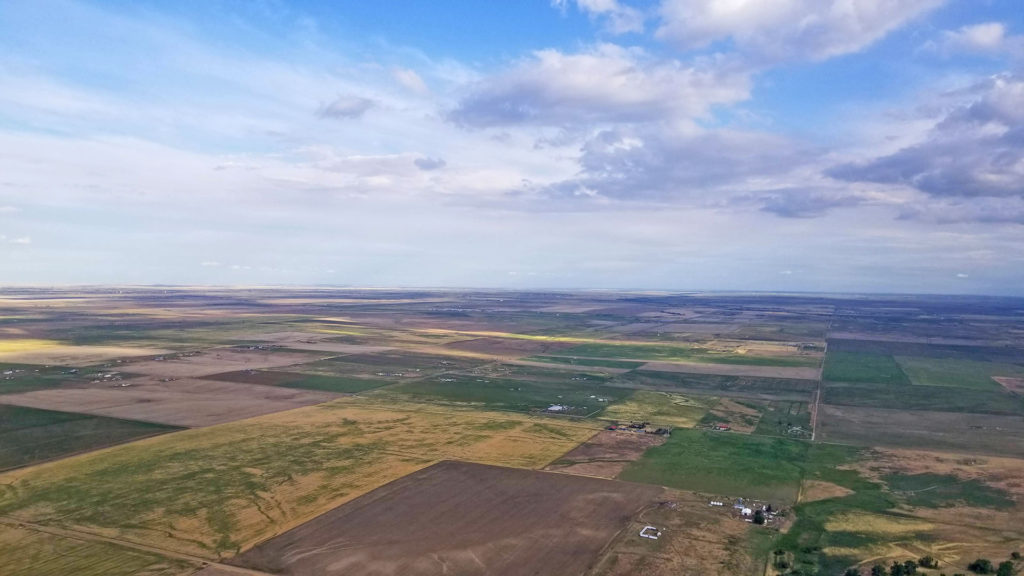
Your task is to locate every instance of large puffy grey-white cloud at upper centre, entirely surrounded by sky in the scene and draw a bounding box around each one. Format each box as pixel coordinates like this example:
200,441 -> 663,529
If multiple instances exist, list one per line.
450,44 -> 750,126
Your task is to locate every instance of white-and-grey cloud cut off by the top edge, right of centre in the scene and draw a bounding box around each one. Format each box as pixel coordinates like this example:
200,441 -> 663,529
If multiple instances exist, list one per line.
656,0 -> 945,64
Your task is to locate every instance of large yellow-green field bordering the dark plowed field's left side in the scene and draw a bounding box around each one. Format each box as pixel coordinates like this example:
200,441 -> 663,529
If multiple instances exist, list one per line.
0,398 -> 598,559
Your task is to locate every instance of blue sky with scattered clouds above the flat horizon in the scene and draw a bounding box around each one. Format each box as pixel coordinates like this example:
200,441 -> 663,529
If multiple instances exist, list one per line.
0,0 -> 1024,295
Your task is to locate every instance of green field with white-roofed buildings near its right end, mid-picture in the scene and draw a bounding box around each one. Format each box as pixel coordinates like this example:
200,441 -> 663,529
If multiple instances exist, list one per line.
382,374 -> 632,416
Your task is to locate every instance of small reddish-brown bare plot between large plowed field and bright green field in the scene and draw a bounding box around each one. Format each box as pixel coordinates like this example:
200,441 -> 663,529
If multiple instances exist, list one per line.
545,430 -> 668,479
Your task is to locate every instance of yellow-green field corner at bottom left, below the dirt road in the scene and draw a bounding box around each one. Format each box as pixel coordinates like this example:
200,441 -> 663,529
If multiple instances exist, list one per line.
0,524 -> 199,576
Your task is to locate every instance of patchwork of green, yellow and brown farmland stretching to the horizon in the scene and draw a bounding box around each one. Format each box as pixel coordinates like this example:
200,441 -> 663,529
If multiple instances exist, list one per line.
0,288 -> 1024,576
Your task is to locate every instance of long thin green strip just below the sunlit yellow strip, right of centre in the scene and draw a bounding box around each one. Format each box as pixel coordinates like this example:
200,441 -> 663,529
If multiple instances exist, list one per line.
561,342 -> 818,367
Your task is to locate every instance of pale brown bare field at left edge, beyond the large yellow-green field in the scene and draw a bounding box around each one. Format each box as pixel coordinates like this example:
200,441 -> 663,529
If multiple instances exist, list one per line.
0,377 -> 341,427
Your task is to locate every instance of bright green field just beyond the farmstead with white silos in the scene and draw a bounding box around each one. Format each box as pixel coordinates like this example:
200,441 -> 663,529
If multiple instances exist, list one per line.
620,429 -> 811,504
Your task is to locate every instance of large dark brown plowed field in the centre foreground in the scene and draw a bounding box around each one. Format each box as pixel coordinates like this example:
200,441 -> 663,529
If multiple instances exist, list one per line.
232,461 -> 663,576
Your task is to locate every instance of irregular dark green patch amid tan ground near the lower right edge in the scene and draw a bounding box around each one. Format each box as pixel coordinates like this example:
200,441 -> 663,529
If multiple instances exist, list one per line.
882,474 -> 1015,509
